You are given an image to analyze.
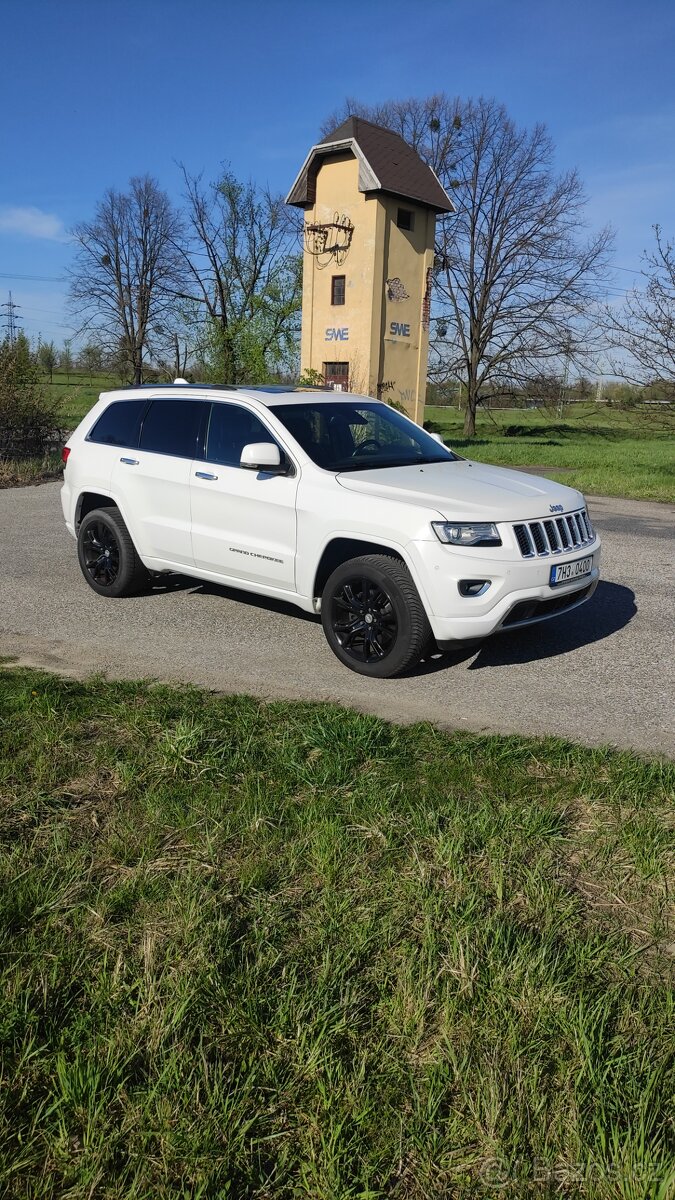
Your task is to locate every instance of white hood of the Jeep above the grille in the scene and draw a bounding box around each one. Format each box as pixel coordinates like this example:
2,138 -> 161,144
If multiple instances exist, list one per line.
338,458 -> 584,521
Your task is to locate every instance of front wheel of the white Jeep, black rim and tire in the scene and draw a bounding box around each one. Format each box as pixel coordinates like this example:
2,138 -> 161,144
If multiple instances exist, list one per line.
321,554 -> 432,679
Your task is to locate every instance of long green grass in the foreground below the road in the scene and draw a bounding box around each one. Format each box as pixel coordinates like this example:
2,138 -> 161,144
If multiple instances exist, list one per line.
0,668 -> 675,1200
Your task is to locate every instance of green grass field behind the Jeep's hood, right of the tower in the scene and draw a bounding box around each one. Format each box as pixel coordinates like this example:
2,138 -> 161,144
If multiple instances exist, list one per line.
425,404 -> 675,502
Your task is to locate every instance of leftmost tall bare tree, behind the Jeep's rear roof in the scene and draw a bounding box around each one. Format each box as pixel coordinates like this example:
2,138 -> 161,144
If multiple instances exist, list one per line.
71,175 -> 181,384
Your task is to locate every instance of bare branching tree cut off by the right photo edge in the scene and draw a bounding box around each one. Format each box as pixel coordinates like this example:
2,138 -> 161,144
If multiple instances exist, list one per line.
607,226 -> 675,403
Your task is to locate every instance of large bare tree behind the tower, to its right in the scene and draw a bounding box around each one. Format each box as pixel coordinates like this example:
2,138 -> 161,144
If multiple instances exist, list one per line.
319,95 -> 613,437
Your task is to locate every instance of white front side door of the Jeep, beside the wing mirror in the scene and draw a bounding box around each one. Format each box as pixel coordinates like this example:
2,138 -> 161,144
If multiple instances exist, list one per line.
191,401 -> 299,592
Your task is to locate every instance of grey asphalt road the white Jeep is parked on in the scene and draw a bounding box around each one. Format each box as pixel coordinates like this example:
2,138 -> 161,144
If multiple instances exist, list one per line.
0,484 -> 675,757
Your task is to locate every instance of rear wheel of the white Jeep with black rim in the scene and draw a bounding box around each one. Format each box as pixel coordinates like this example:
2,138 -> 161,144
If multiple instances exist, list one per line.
77,508 -> 150,596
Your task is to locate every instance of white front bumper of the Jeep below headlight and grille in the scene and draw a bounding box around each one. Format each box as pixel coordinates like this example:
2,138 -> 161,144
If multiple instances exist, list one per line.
408,538 -> 601,643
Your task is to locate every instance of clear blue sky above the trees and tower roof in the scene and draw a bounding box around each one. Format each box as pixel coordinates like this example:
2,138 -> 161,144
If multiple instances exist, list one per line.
0,0 -> 675,344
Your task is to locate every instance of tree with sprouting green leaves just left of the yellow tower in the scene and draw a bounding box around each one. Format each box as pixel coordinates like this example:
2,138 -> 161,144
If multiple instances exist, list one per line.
174,168 -> 301,383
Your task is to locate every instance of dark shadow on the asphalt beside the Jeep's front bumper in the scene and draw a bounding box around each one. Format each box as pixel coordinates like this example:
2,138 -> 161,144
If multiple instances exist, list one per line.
468,580 -> 638,671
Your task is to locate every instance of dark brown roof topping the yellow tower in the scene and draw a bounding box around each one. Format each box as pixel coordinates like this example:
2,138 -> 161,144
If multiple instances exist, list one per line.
287,116 -> 454,212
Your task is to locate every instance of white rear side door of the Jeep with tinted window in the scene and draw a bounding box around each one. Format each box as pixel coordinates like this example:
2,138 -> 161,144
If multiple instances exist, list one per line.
112,397 -> 209,566
